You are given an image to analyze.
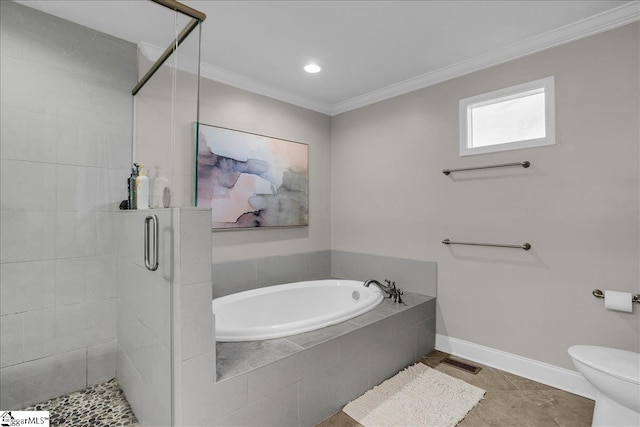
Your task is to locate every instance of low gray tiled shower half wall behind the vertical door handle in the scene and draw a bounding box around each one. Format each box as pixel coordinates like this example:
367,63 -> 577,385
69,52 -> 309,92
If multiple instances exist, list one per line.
115,209 -> 179,426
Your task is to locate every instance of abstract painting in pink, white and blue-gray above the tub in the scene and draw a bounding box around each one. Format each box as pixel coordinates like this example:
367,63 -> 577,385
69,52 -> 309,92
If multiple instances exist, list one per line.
196,123 -> 309,230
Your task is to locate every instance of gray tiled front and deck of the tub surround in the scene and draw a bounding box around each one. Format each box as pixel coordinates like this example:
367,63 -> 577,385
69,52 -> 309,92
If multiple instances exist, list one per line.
182,292 -> 435,426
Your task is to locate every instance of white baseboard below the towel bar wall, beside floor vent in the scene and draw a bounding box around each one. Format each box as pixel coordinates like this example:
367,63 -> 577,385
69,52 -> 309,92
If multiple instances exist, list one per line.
436,334 -> 596,399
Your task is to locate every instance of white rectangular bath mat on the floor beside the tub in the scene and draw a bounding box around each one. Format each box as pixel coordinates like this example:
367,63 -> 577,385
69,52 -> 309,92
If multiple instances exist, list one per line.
343,363 -> 485,427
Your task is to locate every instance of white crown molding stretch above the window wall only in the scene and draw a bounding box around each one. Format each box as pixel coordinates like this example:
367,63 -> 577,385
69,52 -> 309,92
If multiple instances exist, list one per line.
330,1 -> 640,116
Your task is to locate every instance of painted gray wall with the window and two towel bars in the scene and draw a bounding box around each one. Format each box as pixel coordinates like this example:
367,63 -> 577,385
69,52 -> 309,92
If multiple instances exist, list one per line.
331,23 -> 640,369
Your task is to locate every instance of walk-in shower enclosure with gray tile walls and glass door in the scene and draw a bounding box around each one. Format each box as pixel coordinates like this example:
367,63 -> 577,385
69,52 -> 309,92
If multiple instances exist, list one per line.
0,0 -> 204,425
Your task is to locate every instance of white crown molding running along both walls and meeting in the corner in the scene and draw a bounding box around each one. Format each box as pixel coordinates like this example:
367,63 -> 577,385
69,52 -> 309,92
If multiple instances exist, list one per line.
138,0 -> 640,116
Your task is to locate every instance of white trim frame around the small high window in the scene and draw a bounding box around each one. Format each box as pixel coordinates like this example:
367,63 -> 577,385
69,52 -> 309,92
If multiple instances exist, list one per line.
459,76 -> 556,156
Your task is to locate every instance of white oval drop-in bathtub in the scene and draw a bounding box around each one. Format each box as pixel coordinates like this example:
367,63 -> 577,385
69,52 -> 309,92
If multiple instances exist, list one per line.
212,280 -> 384,341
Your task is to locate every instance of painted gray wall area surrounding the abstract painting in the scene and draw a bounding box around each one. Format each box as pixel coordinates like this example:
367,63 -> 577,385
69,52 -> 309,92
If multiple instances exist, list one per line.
200,79 -> 331,262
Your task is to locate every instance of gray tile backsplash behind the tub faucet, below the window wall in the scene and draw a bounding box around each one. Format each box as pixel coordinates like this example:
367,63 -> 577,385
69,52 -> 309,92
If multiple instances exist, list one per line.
331,251 -> 437,296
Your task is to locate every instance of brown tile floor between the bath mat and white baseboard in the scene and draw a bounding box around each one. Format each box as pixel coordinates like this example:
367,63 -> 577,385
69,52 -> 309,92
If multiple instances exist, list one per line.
317,350 -> 594,427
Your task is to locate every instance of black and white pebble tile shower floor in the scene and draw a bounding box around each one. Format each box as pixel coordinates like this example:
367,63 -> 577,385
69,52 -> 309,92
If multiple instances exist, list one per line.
24,379 -> 140,427
